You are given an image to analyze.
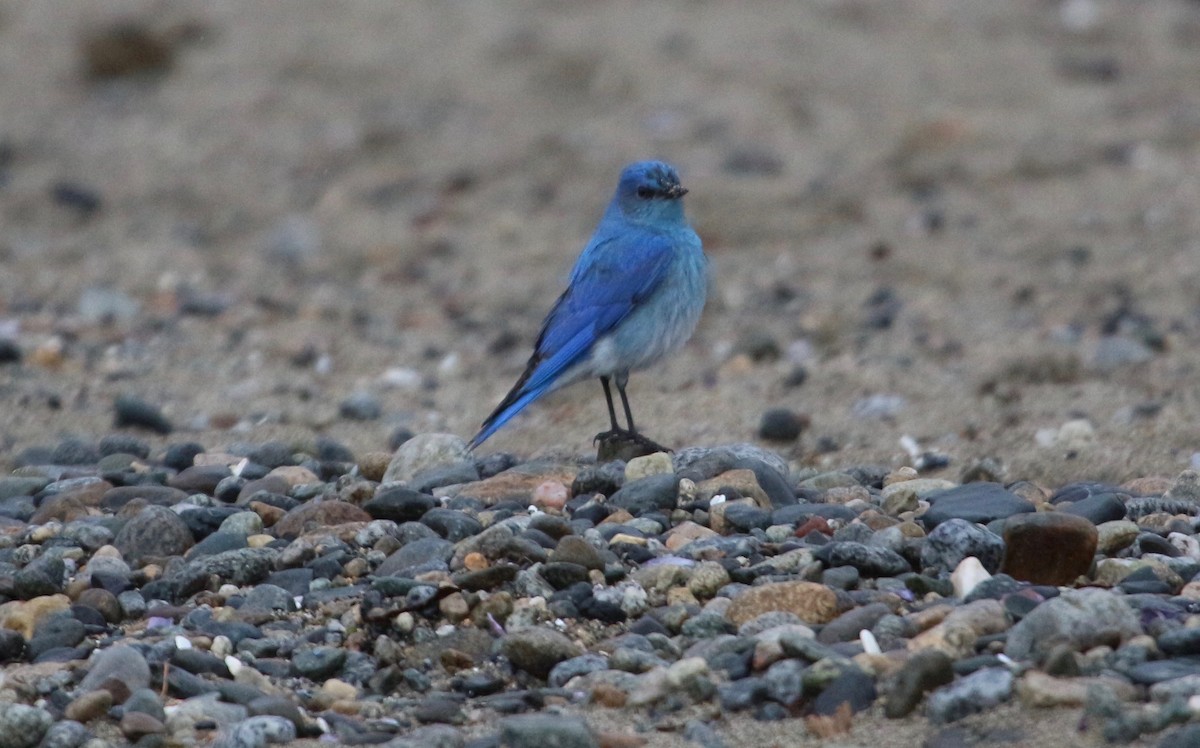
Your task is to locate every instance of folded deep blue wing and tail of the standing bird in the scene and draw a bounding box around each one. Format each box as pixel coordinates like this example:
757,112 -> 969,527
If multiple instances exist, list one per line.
469,227 -> 674,449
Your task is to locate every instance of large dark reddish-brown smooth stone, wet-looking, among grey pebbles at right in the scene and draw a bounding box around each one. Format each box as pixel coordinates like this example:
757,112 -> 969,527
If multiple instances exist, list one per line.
1001,511 -> 1099,586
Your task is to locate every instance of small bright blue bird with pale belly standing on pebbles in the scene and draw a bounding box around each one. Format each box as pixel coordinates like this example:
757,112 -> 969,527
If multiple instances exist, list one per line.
469,161 -> 708,451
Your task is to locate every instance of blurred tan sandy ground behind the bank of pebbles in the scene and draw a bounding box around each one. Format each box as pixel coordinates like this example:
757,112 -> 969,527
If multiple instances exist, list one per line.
0,0 -> 1200,746
